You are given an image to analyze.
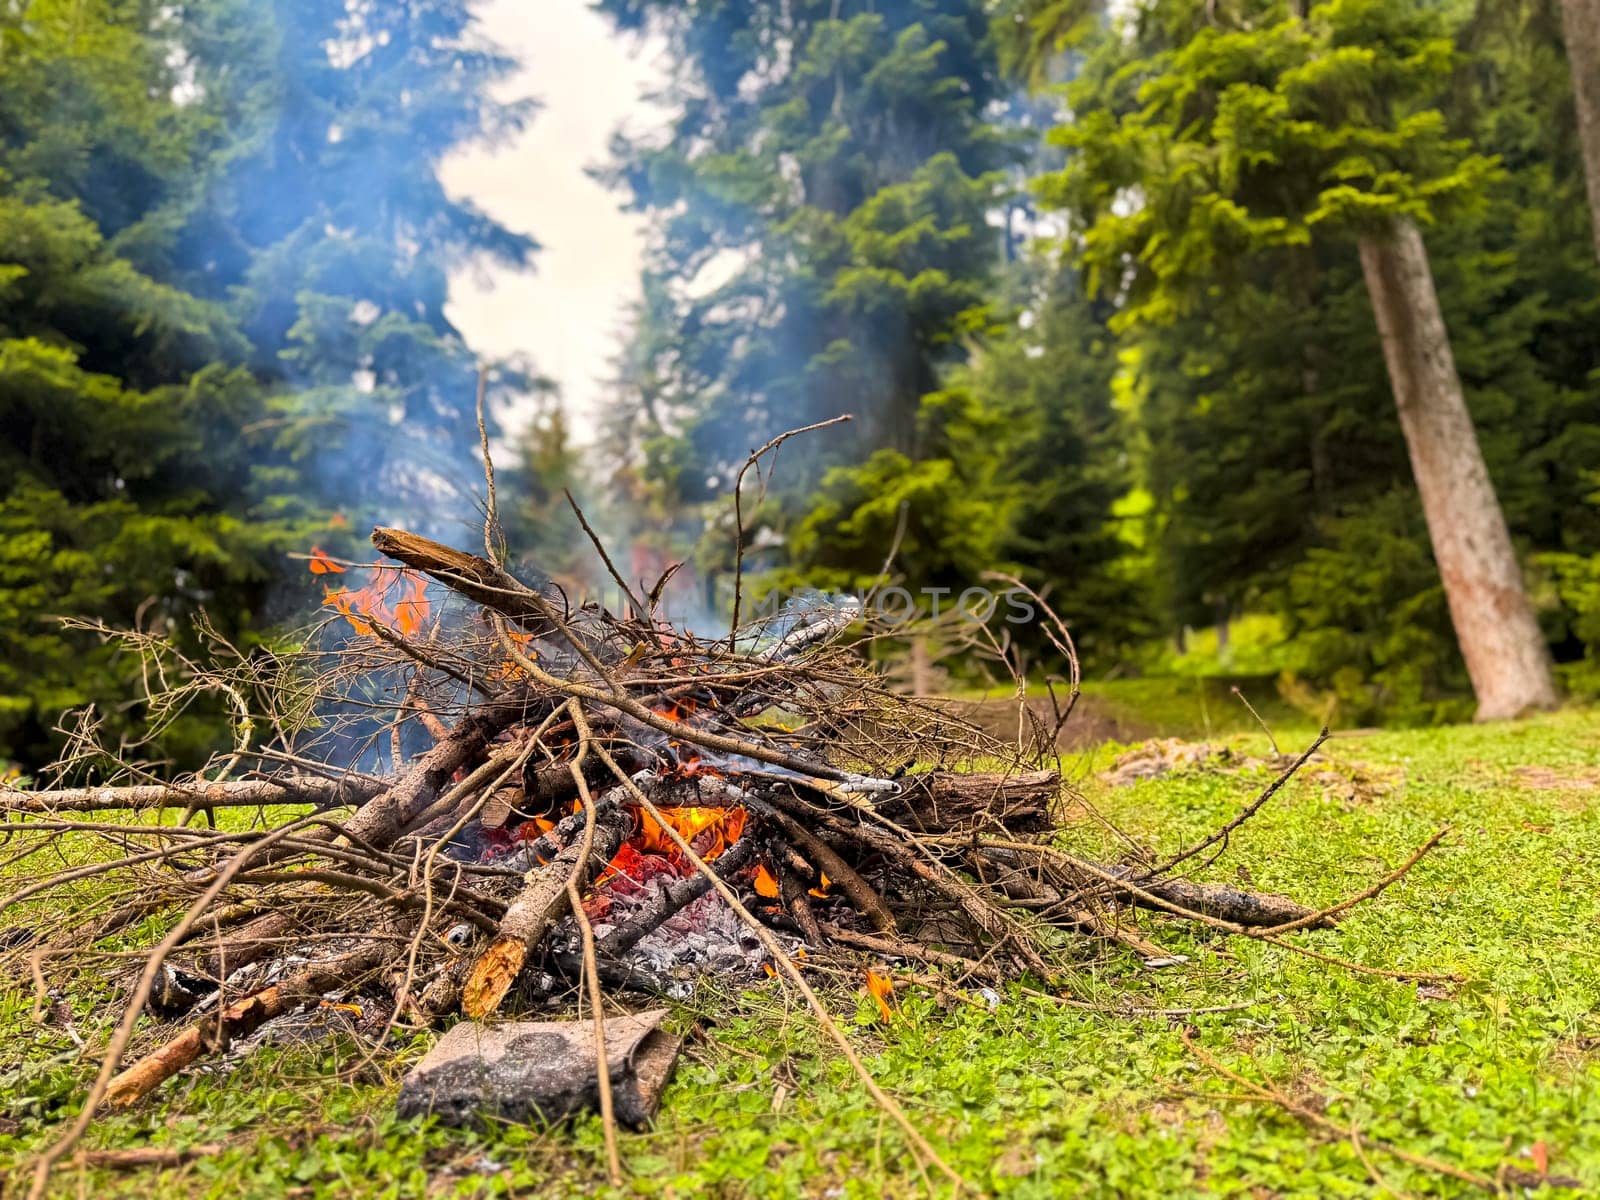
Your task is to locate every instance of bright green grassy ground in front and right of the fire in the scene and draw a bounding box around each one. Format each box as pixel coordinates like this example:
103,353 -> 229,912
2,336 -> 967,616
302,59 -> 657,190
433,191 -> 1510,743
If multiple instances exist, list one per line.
0,712 -> 1600,1197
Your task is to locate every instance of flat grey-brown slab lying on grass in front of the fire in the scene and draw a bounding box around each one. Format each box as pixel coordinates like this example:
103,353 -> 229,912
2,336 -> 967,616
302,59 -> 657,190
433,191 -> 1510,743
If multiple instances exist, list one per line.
395,1008 -> 683,1130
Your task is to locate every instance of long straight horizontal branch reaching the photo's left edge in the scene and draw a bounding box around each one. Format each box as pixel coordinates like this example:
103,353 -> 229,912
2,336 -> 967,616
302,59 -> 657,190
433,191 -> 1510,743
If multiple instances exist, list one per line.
0,776 -> 389,816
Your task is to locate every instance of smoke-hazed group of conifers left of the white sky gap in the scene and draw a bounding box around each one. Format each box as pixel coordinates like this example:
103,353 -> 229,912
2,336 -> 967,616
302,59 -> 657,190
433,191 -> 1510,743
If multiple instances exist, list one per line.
0,0 -> 533,763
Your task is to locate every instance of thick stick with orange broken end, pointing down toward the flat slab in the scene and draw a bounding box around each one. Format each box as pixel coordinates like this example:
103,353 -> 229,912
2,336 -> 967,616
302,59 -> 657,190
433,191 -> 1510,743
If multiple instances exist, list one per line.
461,811 -> 634,1021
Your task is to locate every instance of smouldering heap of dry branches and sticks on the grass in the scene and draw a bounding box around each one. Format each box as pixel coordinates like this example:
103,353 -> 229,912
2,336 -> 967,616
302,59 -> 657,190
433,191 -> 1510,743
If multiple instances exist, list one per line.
0,502 -> 1427,1190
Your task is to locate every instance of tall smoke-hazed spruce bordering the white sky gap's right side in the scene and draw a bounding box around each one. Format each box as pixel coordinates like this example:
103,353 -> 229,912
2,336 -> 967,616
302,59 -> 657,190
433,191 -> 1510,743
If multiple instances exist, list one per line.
600,0 -> 1013,582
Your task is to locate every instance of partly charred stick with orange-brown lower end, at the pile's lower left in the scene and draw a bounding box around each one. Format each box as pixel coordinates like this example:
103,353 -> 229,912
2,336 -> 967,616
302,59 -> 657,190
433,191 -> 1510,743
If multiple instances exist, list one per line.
106,942 -> 394,1109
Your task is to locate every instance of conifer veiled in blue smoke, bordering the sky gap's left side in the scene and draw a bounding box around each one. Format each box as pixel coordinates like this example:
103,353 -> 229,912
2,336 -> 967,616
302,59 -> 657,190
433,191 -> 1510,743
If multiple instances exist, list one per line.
173,0 -> 536,536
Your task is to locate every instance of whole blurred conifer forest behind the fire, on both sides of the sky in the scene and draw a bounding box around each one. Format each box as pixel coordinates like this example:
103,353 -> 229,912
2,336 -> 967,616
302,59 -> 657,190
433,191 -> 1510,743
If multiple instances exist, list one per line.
0,0 -> 1600,770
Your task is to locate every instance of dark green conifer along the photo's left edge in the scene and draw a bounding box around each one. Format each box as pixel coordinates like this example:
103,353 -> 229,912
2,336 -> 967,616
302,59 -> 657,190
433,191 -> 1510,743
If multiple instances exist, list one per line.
0,0 -> 294,763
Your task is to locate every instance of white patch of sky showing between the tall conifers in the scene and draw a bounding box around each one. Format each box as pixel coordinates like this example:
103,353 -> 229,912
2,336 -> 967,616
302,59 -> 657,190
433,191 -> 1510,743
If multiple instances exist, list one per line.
443,0 -> 664,440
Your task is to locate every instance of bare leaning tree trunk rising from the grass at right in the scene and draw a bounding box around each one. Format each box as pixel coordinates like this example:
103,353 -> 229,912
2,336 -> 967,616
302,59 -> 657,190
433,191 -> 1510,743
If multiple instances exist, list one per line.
1360,219 -> 1555,720
